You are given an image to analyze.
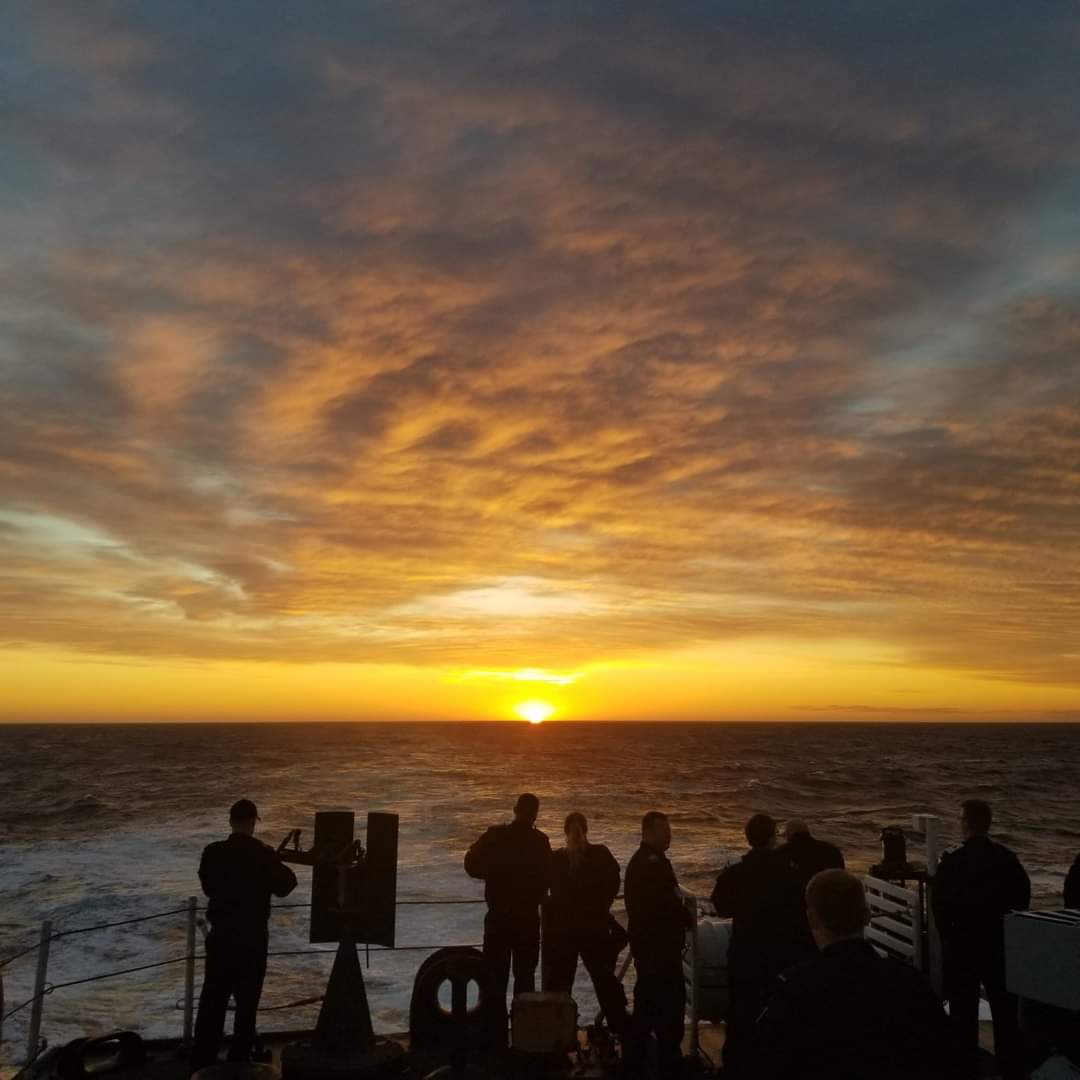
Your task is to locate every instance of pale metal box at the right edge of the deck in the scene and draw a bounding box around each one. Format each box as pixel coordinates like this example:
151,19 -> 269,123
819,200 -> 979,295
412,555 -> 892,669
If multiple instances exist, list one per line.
1005,910 -> 1080,1011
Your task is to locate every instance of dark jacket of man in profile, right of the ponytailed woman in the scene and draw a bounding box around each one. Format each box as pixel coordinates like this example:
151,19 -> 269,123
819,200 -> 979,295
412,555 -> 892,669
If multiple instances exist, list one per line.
623,843 -> 690,964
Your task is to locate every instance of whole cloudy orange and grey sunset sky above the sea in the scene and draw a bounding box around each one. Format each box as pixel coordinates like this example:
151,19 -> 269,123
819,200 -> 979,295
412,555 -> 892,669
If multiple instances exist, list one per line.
0,6 -> 1080,720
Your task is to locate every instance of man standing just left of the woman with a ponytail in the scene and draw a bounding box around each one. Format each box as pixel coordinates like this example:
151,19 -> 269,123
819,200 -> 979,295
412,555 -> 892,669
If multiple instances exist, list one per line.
465,793 -> 551,1000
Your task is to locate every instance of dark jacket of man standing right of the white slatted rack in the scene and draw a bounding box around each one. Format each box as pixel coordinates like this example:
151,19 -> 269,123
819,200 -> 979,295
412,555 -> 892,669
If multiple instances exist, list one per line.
930,836 -> 1031,951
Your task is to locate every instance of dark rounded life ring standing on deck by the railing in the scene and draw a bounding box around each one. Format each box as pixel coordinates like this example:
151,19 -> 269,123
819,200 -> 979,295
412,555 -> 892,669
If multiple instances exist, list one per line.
408,946 -> 507,1050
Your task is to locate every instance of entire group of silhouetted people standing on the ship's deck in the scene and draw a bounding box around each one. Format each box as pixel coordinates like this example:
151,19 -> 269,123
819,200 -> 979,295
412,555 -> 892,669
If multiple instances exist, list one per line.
192,793 -> 1058,1080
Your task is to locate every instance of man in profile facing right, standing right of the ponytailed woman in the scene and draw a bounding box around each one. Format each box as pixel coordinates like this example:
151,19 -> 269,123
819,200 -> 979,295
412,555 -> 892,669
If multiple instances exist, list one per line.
623,810 -> 690,1080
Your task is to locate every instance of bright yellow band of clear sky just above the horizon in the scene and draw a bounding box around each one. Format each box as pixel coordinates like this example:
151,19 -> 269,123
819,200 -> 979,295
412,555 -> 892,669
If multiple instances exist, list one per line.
0,639 -> 1080,723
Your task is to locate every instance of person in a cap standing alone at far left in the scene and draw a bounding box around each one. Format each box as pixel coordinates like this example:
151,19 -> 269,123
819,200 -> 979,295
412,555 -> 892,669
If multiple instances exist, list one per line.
191,799 -> 296,1071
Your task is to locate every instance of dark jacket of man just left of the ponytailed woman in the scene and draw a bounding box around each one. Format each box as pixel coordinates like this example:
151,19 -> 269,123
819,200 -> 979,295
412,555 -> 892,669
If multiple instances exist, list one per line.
465,821 -> 551,916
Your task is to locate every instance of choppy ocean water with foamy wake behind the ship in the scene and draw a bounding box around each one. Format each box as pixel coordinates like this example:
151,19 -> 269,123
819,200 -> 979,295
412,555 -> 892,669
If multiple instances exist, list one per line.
0,724 -> 1080,1063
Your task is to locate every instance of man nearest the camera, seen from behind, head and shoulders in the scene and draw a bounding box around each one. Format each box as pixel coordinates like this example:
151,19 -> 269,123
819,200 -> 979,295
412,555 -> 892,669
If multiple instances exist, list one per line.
752,869 -> 956,1080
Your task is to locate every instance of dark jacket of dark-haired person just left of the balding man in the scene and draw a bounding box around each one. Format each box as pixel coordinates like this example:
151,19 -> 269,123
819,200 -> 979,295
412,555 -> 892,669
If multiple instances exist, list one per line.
713,848 -> 806,978
